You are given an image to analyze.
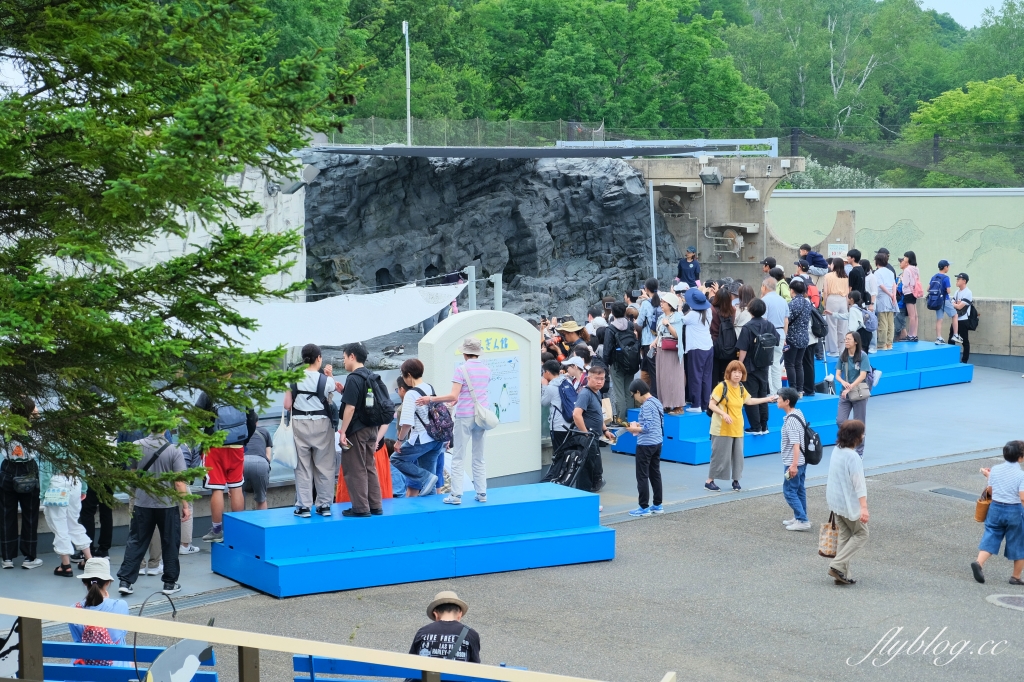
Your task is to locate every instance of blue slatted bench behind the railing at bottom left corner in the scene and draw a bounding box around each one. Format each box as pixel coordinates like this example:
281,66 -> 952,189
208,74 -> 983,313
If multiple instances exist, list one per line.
43,642 -> 217,682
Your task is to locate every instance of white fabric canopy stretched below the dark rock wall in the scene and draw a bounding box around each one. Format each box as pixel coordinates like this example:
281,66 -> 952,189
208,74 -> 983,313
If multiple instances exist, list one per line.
230,283 -> 466,351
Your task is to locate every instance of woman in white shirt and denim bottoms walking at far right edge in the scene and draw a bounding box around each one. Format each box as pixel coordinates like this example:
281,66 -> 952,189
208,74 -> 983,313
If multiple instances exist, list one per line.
971,440 -> 1024,585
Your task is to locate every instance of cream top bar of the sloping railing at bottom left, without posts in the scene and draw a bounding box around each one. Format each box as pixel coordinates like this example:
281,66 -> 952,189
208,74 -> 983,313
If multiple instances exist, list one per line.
0,597 -> 655,682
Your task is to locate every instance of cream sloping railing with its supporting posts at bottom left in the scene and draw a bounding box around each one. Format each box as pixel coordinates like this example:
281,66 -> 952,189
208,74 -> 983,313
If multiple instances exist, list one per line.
0,598 -> 676,682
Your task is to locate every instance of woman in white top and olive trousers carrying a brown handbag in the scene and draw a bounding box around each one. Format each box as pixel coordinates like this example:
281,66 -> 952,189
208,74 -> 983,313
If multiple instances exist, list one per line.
819,419 -> 870,585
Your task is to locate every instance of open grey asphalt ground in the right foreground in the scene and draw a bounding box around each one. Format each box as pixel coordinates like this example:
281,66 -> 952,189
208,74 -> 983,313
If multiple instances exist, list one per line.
83,452 -> 1024,682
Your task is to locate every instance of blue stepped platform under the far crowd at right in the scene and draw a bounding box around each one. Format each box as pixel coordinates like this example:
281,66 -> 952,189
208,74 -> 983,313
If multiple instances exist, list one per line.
611,341 -> 974,465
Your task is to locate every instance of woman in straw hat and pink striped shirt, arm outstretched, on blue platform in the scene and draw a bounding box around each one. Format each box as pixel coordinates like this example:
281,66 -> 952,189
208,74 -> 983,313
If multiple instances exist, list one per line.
416,335 -> 491,505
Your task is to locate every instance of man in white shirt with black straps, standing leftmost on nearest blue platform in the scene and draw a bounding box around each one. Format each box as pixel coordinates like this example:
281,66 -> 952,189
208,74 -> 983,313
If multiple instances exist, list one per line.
285,343 -> 338,518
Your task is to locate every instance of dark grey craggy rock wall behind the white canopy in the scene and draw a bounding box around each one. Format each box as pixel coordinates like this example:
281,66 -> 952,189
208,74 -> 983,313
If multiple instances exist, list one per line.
303,153 -> 679,319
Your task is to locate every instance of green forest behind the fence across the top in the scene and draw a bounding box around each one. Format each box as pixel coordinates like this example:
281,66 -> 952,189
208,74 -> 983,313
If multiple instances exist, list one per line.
267,0 -> 1024,187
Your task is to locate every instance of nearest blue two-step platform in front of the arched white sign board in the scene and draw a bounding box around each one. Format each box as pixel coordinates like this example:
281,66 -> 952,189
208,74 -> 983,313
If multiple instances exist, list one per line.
212,483 -> 615,597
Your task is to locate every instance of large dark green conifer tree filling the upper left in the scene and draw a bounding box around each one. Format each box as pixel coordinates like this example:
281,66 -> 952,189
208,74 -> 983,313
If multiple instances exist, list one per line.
0,0 -> 358,489
